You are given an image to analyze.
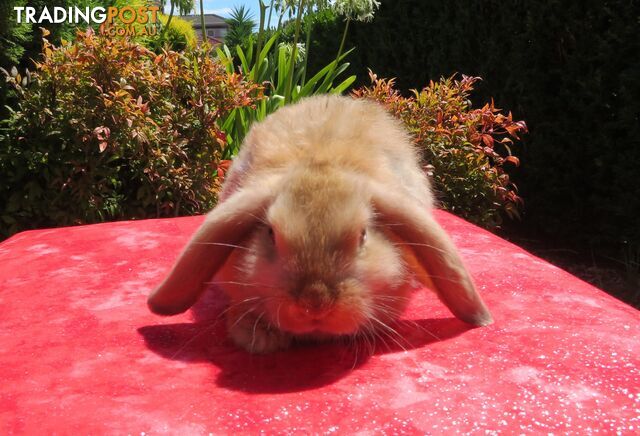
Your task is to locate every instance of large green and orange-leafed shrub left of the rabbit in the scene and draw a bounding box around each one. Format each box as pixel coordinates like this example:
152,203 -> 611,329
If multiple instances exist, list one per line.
0,30 -> 261,235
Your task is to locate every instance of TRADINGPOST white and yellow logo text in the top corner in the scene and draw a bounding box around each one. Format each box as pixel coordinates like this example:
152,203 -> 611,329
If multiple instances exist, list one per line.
13,6 -> 160,36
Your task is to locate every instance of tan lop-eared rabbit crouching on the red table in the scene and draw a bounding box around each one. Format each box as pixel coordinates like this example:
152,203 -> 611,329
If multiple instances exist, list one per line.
148,95 -> 492,353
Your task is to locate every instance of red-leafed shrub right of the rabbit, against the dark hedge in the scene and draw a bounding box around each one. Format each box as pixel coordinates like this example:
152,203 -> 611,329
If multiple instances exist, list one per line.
353,73 -> 527,228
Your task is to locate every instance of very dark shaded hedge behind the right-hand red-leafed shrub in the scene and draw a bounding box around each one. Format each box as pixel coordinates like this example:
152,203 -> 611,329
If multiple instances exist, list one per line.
311,0 -> 640,250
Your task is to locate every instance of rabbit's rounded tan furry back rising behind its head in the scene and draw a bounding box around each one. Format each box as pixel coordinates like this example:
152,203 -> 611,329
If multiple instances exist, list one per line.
223,95 -> 432,208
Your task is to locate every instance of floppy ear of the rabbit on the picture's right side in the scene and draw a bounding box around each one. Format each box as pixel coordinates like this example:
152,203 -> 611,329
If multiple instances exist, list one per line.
373,190 -> 493,326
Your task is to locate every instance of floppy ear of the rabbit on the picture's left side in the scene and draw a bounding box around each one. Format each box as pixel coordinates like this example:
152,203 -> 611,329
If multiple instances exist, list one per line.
147,189 -> 271,315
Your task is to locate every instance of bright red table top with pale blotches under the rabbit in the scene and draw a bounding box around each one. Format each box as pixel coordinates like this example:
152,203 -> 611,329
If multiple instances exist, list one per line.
0,212 -> 640,434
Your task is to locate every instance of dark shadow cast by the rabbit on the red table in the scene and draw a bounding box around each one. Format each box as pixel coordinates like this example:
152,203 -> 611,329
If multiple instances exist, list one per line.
138,288 -> 472,393
